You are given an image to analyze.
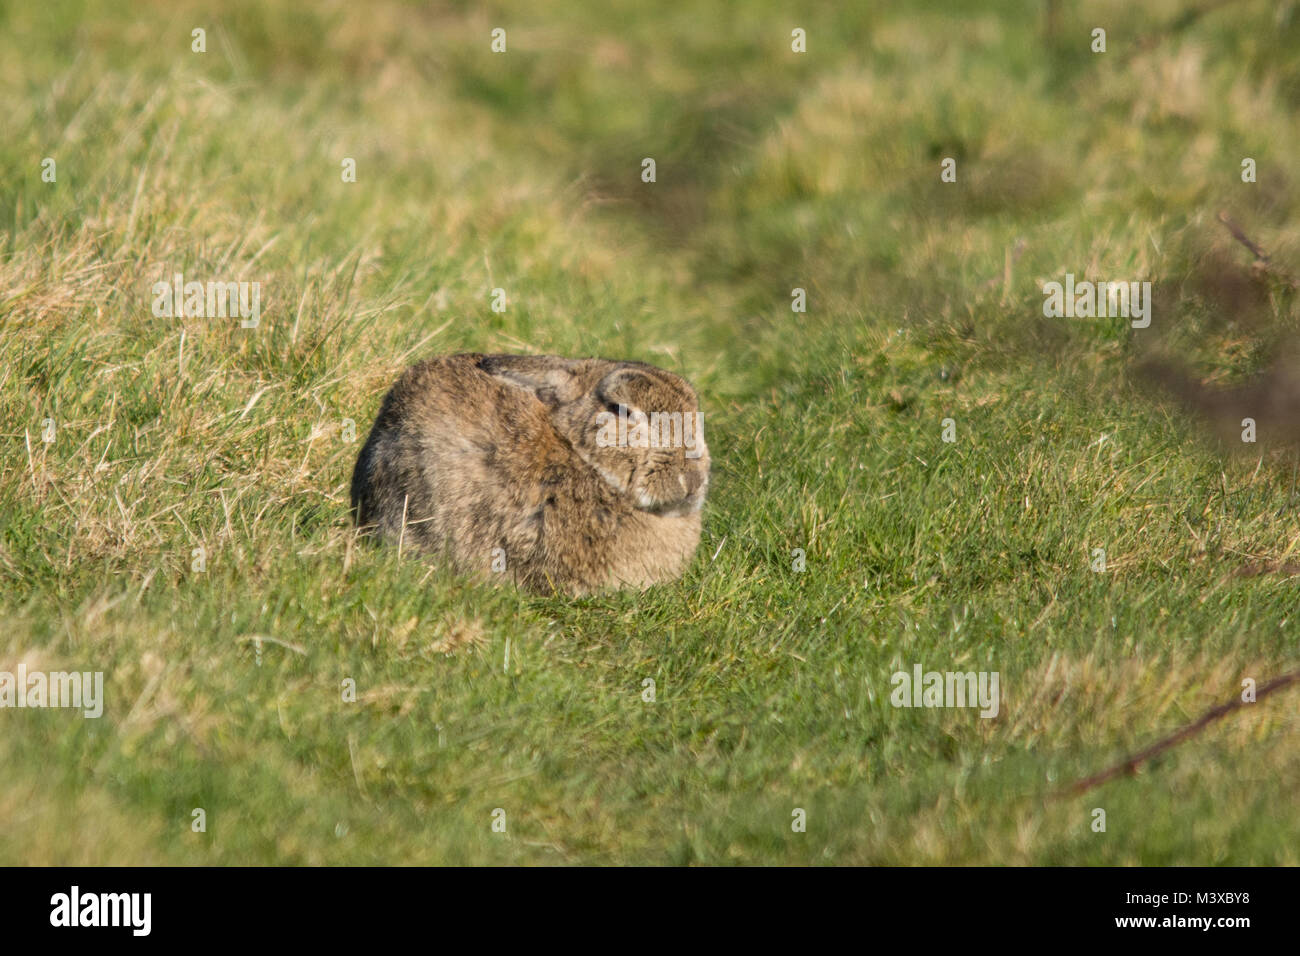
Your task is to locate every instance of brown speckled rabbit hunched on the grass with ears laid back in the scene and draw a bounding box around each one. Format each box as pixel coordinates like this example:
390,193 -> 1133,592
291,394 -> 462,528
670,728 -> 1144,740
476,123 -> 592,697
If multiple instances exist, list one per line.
351,354 -> 710,597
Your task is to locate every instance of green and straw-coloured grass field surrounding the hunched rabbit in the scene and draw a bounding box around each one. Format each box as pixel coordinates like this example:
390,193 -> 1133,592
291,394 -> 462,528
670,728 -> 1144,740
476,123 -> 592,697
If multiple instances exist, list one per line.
0,0 -> 1300,865
